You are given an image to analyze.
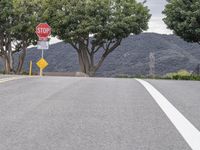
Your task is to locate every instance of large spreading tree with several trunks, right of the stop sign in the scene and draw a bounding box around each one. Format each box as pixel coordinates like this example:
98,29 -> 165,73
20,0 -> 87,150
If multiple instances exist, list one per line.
46,0 -> 151,76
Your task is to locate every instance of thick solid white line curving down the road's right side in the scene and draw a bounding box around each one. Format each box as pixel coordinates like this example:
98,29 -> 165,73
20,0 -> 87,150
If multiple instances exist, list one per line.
136,79 -> 200,150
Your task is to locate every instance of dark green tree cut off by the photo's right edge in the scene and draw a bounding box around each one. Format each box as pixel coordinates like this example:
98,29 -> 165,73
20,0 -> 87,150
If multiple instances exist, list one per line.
163,0 -> 200,44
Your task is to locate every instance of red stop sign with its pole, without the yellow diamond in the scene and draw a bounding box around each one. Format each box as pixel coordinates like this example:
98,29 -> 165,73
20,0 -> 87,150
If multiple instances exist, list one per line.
35,23 -> 51,76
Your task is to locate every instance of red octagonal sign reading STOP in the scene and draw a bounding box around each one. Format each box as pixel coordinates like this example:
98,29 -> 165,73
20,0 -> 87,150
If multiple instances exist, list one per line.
35,23 -> 51,40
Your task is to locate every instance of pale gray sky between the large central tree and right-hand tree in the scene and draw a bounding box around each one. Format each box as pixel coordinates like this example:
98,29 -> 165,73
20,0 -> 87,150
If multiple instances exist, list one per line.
138,0 -> 172,34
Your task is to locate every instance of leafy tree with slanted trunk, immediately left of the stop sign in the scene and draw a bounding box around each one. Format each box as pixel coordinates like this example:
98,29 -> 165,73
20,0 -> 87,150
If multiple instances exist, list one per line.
12,0 -> 42,74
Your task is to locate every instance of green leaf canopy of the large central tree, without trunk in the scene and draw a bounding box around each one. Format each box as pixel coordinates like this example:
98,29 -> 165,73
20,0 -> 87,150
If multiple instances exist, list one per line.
48,0 -> 150,43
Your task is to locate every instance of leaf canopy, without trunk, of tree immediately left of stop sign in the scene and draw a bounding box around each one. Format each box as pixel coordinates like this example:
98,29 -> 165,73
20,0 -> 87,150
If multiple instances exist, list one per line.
12,0 -> 41,45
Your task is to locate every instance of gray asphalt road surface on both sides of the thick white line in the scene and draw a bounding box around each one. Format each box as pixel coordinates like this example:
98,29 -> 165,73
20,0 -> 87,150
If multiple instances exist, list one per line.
0,76 -> 200,150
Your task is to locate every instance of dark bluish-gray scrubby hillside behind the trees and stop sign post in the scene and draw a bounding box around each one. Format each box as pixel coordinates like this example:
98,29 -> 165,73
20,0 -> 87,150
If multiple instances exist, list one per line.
2,33 -> 200,77
